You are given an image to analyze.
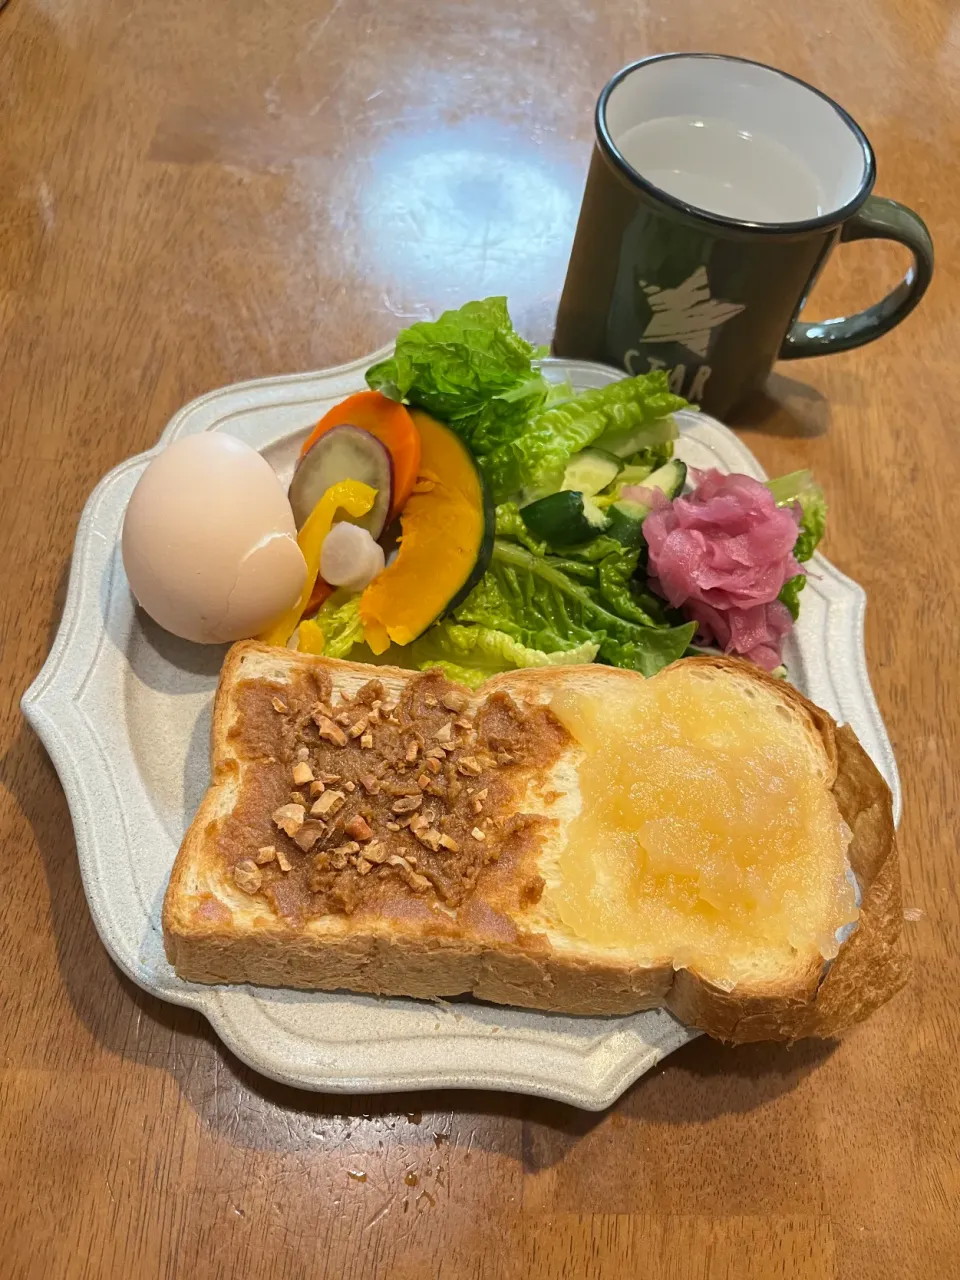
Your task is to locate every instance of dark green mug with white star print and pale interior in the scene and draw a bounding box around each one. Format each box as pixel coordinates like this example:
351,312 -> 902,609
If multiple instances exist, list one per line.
553,54 -> 933,416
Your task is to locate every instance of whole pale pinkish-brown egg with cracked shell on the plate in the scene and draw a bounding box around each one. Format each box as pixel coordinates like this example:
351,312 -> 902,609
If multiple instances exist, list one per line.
122,431 -> 307,644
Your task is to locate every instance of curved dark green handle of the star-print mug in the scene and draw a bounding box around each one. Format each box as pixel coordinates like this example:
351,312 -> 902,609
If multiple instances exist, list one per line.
778,196 -> 933,360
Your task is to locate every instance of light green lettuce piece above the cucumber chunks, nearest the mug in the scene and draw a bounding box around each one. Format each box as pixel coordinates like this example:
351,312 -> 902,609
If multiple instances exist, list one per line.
480,371 -> 686,503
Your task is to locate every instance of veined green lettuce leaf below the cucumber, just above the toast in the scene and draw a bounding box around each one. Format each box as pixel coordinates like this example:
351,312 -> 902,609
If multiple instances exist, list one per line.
456,538 -> 696,676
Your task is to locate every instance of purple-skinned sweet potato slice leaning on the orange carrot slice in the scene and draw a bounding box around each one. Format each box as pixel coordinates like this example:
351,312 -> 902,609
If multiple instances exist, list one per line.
288,422 -> 393,538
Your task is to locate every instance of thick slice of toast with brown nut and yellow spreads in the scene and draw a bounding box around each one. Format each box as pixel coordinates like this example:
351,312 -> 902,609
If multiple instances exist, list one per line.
163,641 -> 906,1041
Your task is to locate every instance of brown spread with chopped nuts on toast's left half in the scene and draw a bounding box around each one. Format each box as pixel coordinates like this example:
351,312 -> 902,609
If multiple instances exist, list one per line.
248,670 -> 561,916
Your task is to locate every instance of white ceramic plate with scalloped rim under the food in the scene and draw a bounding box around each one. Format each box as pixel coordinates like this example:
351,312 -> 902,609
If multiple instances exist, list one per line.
23,348 -> 900,1110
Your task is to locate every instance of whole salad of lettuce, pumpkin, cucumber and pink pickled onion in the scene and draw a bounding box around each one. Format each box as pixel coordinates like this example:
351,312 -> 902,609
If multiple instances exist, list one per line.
261,297 -> 826,686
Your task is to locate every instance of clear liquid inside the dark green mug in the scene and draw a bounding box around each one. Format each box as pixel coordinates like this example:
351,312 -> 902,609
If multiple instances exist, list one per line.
617,115 -> 826,223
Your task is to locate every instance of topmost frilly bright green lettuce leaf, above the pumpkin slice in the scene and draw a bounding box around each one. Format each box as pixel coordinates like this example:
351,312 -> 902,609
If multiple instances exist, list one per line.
366,298 -> 549,456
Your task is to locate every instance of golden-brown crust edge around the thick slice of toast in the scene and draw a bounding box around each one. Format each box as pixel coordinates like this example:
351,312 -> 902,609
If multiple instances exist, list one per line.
163,641 -> 908,1042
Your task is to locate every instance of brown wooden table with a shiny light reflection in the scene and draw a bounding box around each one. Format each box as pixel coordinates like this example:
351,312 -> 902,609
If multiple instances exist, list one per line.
0,0 -> 960,1280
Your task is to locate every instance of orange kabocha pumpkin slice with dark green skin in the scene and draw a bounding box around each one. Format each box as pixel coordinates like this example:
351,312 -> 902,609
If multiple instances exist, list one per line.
360,410 -> 494,653
